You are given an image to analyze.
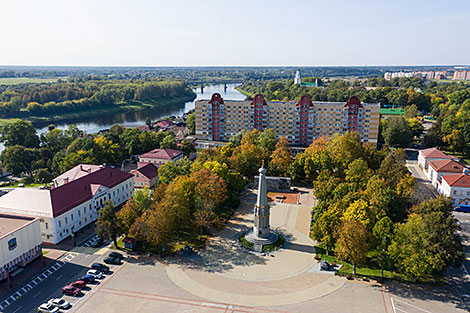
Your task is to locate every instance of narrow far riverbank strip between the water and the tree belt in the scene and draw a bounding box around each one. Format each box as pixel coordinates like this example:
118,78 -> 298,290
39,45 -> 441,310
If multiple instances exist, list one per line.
0,94 -> 196,127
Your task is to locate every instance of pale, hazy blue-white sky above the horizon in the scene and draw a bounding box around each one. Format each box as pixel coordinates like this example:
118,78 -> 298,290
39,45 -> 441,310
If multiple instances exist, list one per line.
0,0 -> 470,66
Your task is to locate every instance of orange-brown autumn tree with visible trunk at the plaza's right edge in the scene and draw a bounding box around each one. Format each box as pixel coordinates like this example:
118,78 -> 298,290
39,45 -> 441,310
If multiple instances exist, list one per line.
336,220 -> 369,274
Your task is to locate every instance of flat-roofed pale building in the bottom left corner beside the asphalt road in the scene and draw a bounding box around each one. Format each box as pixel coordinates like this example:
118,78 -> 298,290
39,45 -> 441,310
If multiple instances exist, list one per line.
0,214 -> 42,281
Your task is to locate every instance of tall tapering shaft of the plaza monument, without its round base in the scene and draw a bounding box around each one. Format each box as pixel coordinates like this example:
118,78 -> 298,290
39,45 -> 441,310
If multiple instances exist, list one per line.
253,166 -> 271,238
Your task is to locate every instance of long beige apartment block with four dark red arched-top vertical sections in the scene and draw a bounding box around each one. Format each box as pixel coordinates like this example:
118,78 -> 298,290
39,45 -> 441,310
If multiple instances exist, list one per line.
195,93 -> 380,147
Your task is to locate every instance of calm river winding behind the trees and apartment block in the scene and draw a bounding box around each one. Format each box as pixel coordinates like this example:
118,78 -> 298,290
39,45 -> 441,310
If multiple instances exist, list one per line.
34,84 -> 245,134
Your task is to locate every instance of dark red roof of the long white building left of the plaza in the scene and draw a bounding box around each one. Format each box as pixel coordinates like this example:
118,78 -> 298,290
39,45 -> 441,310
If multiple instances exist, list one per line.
50,167 -> 133,217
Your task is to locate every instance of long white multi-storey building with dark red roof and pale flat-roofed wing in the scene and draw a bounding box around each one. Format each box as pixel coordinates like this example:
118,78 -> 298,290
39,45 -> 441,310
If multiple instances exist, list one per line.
0,165 -> 134,244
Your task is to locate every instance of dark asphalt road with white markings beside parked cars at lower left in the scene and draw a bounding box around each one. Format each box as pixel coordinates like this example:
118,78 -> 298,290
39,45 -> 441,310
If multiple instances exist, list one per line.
3,236 -> 113,313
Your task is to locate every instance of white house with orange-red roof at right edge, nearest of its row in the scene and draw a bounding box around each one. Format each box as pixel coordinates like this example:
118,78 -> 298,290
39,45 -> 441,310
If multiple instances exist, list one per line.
438,169 -> 470,208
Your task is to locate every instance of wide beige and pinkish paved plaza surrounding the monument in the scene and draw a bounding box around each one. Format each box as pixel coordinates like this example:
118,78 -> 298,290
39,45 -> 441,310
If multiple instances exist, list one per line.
56,189 -> 467,313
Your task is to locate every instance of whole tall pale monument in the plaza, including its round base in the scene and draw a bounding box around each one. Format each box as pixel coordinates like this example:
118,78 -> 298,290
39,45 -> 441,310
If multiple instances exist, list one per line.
245,166 -> 278,251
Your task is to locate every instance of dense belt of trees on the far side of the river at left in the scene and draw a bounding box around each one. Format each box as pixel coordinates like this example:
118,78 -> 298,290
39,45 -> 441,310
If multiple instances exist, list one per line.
0,79 -> 195,118
